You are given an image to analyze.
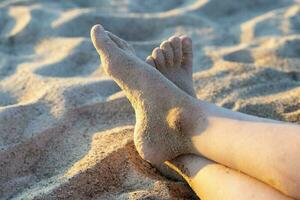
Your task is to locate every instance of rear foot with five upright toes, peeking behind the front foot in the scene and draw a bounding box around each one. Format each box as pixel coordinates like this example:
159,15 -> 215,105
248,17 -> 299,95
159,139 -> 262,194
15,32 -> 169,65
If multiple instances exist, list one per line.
146,36 -> 196,97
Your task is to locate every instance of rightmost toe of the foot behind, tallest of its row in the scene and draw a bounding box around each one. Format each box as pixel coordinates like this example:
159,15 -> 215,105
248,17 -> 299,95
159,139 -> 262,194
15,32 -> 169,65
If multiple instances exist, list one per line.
180,36 -> 193,68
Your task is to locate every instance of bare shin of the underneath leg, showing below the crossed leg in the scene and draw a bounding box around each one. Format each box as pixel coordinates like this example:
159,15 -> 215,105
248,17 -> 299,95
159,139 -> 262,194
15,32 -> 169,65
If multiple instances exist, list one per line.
168,155 -> 292,200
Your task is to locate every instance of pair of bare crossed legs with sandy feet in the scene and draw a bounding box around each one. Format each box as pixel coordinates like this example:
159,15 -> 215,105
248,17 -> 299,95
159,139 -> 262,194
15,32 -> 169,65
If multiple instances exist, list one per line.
91,25 -> 300,200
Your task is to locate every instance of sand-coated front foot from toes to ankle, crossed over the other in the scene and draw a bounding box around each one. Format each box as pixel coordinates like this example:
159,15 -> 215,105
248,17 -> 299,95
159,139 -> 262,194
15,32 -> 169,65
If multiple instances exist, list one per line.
91,25 -> 206,164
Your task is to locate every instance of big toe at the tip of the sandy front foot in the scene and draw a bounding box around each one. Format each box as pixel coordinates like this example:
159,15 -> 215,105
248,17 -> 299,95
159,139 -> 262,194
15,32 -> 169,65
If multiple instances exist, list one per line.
91,24 -> 117,56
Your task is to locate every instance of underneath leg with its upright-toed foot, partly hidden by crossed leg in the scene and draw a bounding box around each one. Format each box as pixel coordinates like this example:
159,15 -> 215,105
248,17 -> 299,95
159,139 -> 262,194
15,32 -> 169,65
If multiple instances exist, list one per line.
146,36 -> 291,200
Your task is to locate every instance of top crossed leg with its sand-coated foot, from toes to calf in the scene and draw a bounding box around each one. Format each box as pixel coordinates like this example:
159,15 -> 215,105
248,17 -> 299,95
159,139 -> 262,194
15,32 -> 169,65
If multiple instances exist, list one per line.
91,25 -> 300,198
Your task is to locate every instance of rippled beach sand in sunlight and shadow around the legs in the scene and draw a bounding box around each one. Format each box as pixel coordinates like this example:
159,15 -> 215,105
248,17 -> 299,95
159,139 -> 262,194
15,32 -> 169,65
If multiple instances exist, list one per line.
0,0 -> 300,200
